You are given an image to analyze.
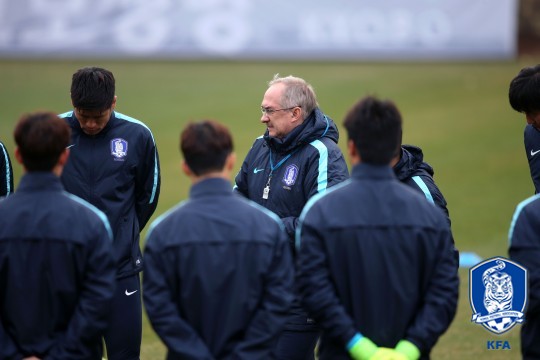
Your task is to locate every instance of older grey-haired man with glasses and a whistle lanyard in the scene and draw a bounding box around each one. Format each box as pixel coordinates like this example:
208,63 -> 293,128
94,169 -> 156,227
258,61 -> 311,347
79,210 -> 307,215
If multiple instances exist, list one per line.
235,74 -> 349,360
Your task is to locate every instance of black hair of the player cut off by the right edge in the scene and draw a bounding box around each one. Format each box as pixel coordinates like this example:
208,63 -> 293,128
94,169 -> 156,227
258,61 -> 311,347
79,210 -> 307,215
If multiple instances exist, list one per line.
508,64 -> 540,114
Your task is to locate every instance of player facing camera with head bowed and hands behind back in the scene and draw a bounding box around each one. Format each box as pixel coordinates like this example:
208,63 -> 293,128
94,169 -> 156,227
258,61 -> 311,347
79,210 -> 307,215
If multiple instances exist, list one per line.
61,67 -> 160,360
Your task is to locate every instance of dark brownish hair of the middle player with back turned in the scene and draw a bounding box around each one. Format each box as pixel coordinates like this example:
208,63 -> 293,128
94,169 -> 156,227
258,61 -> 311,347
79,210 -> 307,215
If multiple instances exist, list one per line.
180,120 -> 233,176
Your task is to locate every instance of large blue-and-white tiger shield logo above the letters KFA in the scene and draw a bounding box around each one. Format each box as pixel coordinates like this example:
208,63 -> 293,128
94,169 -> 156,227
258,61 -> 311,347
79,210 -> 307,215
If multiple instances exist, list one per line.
469,257 -> 527,334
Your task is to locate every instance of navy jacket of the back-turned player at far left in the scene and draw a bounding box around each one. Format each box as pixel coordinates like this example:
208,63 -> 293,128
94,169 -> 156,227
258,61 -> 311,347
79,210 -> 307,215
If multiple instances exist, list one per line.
0,172 -> 116,360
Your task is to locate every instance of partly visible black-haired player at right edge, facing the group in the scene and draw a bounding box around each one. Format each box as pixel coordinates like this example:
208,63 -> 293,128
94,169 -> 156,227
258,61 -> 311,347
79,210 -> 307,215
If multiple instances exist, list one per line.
508,64 -> 540,193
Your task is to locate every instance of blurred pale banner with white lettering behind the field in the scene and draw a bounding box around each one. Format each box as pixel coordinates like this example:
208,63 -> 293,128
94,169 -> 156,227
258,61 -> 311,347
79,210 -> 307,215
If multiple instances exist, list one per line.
0,0 -> 518,60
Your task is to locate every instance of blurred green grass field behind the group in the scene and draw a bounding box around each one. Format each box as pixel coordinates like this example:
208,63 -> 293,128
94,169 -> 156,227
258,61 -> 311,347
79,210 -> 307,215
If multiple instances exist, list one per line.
0,58 -> 540,360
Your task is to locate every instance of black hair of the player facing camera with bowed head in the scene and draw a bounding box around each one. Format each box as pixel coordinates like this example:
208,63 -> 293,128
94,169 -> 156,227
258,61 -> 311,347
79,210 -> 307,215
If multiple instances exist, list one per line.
71,67 -> 115,111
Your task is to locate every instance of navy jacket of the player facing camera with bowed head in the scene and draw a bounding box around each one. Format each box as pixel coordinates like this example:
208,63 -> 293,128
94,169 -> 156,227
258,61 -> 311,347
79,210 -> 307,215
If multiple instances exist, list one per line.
60,111 -> 161,278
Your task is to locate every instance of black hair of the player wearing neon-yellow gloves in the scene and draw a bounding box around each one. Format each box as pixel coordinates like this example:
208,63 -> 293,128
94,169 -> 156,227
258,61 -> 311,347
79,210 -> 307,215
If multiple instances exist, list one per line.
343,96 -> 402,165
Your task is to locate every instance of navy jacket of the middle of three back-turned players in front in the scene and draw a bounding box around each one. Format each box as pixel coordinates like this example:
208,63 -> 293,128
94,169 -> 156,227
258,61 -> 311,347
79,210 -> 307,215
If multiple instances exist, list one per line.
143,178 -> 294,360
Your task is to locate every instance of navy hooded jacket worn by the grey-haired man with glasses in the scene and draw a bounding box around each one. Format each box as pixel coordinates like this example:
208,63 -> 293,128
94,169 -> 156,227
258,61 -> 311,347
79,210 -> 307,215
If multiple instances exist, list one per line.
235,109 -> 349,244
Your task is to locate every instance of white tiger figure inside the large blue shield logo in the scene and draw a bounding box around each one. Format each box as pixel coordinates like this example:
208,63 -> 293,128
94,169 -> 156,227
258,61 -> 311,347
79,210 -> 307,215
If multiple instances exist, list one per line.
482,260 -> 514,314
